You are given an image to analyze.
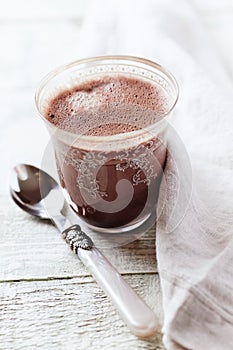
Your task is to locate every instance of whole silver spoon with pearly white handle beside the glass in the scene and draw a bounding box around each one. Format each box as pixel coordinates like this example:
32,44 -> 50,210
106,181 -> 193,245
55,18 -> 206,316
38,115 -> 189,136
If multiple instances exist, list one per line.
10,164 -> 159,337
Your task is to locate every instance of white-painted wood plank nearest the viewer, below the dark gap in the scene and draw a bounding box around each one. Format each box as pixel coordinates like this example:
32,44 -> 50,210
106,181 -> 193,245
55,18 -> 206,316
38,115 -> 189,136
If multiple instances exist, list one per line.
0,275 -> 164,350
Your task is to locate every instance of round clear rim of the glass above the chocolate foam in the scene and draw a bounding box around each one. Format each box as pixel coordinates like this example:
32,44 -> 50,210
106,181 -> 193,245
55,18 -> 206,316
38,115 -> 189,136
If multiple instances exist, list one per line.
35,55 -> 179,143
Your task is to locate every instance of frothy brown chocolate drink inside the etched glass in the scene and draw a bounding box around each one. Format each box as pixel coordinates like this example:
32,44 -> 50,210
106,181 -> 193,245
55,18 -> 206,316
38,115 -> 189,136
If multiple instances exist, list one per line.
46,75 -> 169,228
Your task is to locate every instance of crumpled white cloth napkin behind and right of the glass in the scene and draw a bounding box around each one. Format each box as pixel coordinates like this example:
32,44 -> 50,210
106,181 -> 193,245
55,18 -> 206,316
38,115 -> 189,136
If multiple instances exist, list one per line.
80,0 -> 233,350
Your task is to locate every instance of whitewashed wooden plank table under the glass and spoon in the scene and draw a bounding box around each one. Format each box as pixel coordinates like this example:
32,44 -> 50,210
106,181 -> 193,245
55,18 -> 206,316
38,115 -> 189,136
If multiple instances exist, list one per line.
0,0 -> 233,350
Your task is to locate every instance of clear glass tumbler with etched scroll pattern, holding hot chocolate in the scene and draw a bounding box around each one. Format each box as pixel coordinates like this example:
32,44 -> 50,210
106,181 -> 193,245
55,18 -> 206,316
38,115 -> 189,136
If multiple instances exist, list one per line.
36,56 -> 178,232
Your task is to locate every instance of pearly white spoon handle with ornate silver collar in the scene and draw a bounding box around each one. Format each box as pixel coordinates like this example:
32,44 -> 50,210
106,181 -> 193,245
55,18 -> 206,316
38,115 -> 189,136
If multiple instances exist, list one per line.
62,225 -> 159,337
